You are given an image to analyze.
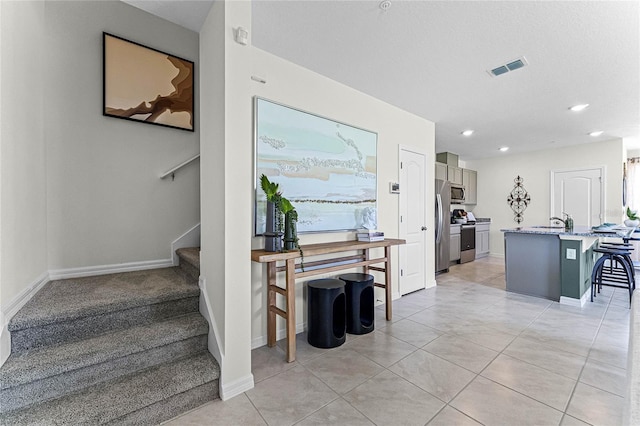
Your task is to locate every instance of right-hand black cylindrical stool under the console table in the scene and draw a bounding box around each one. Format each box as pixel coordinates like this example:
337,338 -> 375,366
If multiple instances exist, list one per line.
338,273 -> 375,334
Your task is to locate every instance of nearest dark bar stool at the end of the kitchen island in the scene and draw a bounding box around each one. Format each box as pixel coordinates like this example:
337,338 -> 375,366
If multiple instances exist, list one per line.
591,247 -> 635,306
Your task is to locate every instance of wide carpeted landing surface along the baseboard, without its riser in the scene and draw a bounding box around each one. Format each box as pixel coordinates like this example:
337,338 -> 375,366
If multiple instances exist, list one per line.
8,268 -> 200,332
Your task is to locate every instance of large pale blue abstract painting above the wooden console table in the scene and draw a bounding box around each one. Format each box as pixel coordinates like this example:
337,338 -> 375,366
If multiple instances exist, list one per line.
254,97 -> 378,235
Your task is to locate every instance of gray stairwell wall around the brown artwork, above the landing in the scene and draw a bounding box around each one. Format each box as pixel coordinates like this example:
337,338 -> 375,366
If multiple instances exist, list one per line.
42,1 -> 200,270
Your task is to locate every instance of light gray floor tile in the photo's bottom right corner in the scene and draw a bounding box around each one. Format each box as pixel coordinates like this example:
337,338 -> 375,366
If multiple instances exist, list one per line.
567,383 -> 624,425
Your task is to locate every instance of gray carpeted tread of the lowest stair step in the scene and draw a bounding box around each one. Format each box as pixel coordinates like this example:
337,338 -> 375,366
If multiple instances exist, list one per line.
2,352 -> 220,426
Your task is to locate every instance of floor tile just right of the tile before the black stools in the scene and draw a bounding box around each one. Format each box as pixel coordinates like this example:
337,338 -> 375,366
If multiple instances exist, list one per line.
389,350 -> 476,402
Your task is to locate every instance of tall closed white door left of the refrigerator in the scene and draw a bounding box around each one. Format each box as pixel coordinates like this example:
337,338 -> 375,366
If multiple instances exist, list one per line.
399,149 -> 427,294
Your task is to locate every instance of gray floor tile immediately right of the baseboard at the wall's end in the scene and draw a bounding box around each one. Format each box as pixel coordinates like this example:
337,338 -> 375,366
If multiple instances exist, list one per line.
245,365 -> 338,425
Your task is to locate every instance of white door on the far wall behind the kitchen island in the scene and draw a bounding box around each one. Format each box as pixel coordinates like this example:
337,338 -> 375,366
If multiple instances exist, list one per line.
551,168 -> 604,227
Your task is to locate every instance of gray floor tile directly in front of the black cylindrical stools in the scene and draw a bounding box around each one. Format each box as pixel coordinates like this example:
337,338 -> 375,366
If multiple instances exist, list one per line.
305,348 -> 382,394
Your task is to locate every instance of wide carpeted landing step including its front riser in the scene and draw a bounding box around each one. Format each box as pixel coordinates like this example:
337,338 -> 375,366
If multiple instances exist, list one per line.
8,268 -> 200,353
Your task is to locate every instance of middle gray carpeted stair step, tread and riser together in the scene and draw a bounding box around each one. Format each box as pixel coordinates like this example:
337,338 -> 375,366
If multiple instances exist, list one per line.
0,313 -> 209,413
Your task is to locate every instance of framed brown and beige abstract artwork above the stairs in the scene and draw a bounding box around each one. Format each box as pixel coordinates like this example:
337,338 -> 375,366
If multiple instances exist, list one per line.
102,33 -> 194,132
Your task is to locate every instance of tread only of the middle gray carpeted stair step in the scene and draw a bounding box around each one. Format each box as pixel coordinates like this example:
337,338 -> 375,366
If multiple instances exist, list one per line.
0,313 -> 209,392
